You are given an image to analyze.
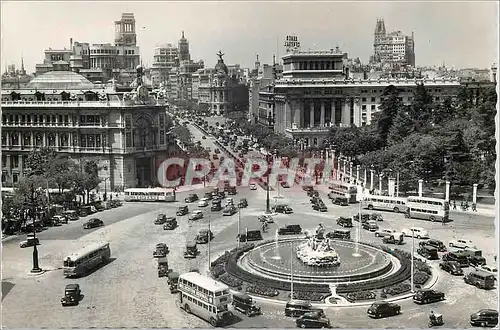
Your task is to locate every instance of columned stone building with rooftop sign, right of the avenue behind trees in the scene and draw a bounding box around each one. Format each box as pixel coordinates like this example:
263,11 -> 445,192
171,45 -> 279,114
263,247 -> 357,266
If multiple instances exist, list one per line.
266,48 -> 460,146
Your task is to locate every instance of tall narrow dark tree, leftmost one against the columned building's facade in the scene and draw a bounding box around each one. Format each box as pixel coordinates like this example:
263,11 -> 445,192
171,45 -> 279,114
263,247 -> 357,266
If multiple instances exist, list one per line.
374,85 -> 403,145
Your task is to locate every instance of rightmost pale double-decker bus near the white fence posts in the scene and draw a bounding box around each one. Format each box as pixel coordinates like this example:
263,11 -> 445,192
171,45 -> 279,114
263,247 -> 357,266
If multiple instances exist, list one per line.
406,196 -> 450,221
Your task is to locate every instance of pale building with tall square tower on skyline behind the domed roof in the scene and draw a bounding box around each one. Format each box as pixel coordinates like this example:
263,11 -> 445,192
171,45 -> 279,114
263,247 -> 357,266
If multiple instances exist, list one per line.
35,13 -> 140,84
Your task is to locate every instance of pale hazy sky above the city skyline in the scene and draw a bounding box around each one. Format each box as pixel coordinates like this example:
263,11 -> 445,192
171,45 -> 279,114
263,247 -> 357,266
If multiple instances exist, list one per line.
1,1 -> 499,72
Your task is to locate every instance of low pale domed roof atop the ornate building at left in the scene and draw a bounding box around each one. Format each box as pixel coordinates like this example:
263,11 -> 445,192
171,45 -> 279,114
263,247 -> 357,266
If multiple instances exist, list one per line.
27,71 -> 93,89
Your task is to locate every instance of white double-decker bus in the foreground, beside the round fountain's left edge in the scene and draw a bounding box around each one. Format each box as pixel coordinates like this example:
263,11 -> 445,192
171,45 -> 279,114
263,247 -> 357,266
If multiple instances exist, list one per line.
179,272 -> 233,327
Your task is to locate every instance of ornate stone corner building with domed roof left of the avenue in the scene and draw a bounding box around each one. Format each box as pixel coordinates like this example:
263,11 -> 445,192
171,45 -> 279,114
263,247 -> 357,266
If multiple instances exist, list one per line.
1,66 -> 173,190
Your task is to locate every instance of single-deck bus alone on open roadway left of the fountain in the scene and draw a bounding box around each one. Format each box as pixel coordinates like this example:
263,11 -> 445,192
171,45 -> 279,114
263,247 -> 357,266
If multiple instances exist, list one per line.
63,242 -> 111,277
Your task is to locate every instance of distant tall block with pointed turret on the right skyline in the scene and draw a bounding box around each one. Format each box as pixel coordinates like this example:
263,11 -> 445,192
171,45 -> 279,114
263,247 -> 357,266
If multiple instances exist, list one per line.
370,19 -> 415,67
